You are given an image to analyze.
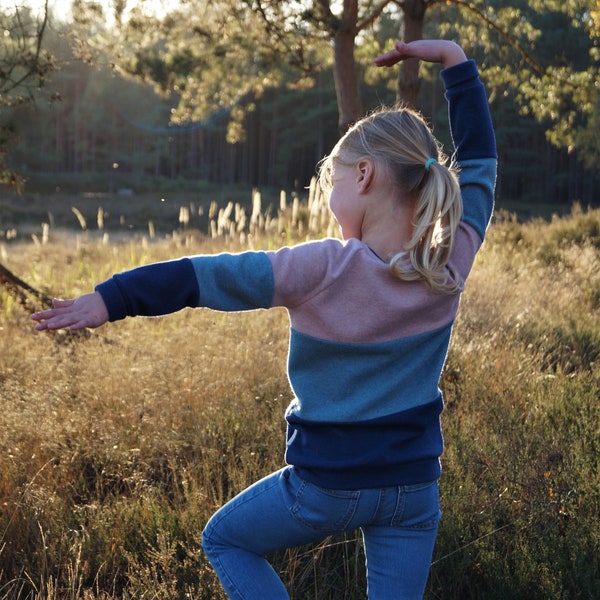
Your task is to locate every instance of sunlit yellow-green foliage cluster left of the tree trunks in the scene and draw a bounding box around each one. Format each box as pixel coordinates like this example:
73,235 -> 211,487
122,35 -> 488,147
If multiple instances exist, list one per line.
115,2 -> 328,135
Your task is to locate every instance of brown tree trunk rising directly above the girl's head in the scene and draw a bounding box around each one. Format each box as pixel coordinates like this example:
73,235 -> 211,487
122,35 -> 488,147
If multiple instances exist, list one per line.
333,0 -> 363,133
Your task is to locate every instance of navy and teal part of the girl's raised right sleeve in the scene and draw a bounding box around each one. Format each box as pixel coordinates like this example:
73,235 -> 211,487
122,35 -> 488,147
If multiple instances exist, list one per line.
441,60 -> 497,240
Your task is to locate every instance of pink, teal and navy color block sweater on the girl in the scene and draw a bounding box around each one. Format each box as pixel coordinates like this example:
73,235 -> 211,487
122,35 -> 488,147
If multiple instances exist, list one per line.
96,61 -> 496,489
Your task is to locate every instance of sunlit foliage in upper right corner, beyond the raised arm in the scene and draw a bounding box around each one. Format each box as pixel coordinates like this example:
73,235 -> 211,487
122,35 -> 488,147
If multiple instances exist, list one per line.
441,0 -> 600,172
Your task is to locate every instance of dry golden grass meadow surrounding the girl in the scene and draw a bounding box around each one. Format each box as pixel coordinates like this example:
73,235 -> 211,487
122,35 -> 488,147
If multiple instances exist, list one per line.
0,186 -> 600,600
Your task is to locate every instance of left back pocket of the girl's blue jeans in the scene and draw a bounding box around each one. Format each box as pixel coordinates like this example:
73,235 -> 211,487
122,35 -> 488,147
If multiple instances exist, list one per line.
291,476 -> 360,533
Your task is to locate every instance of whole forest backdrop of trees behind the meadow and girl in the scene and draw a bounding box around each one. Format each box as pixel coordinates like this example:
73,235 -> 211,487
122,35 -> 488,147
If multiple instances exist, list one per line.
0,0 -> 600,210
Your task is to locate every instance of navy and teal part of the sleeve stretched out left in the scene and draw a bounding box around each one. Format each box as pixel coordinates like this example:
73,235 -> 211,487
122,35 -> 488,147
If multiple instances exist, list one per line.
96,252 -> 273,321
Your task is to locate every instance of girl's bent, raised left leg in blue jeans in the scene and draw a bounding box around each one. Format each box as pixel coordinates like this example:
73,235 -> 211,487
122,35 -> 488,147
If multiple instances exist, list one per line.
202,467 -> 357,600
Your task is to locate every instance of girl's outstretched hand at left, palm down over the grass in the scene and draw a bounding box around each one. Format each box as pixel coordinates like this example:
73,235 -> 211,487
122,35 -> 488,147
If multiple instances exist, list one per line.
31,292 -> 108,331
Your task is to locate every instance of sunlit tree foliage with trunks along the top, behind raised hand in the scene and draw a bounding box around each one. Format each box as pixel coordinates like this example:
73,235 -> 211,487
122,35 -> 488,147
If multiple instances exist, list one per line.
94,0 -> 600,165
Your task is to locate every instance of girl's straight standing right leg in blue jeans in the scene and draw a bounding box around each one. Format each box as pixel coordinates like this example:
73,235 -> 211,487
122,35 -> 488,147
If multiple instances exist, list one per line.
362,482 -> 440,600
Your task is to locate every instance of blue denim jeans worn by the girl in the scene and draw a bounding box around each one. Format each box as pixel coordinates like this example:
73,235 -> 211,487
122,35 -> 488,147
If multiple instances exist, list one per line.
202,467 -> 441,600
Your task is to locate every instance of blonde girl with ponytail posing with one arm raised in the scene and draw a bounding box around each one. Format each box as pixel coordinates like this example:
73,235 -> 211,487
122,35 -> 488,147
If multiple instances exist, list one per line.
32,40 -> 496,600
